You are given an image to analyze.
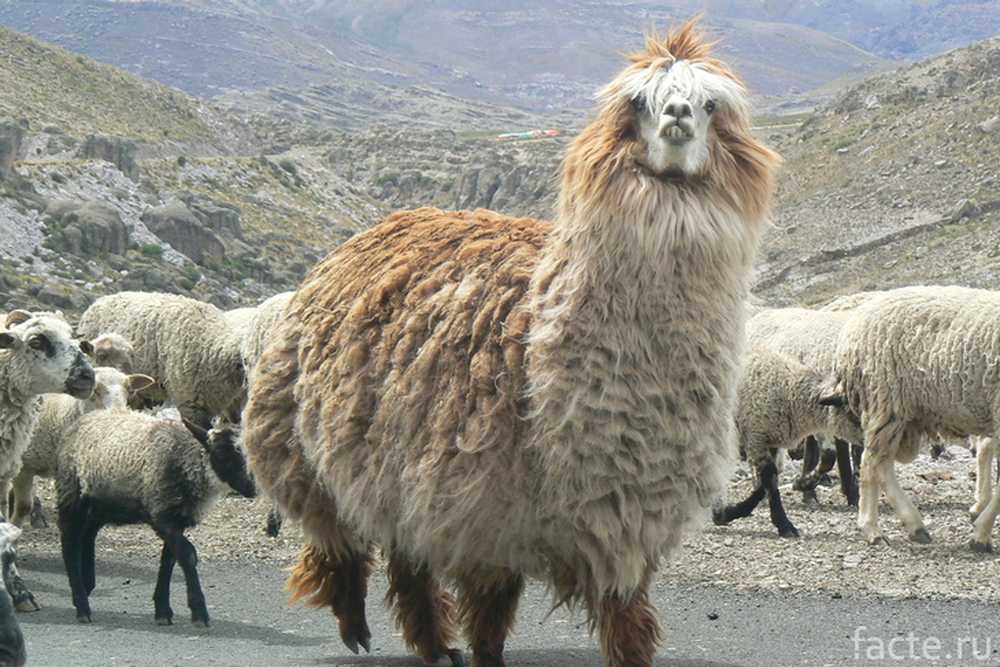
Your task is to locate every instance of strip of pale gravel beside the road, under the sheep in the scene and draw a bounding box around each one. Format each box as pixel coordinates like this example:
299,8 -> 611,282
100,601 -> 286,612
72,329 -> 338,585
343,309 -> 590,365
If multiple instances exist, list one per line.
19,440 -> 1000,604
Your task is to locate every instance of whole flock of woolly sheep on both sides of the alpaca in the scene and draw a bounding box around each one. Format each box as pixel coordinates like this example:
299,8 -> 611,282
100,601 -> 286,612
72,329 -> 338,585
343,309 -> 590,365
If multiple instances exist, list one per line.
0,286 -> 1000,664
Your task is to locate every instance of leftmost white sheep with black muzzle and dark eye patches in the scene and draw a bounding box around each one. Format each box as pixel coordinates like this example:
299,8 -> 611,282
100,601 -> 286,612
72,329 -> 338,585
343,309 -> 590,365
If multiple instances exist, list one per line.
0,310 -> 94,611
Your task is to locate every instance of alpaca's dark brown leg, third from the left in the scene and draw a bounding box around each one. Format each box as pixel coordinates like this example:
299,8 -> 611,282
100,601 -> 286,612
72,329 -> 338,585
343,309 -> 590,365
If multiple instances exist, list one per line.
452,571 -> 524,667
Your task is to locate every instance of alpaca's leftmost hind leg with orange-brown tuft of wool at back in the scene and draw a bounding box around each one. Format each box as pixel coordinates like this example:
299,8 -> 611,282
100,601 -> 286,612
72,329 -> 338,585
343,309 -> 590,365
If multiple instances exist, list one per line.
288,544 -> 372,653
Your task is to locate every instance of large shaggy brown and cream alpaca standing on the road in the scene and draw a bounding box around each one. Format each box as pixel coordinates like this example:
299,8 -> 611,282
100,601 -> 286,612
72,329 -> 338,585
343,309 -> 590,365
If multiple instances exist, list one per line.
244,22 -> 780,667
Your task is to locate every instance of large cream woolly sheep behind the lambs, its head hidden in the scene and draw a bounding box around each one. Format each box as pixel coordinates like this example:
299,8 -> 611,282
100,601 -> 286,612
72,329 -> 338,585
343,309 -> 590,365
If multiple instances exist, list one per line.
78,292 -> 245,427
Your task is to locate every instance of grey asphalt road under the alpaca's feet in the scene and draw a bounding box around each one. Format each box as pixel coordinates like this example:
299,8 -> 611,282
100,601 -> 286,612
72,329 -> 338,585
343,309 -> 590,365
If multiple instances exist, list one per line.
13,552 -> 1000,667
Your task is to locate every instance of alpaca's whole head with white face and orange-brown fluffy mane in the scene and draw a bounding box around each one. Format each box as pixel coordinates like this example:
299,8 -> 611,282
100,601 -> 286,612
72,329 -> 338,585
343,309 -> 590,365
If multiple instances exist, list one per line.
561,20 -> 780,220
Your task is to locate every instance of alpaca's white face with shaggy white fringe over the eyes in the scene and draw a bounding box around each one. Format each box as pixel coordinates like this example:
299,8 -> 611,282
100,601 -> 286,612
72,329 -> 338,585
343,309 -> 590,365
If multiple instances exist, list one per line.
622,60 -> 746,179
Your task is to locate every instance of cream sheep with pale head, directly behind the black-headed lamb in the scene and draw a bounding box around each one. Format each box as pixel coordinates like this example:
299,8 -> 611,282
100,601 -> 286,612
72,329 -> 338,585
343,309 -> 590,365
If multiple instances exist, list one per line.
10,368 -> 156,527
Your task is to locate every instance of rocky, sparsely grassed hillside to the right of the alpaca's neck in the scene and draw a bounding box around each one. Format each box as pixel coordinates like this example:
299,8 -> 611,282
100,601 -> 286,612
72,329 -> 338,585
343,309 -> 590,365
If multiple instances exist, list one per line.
757,38 -> 1000,303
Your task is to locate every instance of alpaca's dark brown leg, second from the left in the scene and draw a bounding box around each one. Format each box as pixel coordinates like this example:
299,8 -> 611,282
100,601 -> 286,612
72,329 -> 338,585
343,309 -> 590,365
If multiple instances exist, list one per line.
385,551 -> 465,667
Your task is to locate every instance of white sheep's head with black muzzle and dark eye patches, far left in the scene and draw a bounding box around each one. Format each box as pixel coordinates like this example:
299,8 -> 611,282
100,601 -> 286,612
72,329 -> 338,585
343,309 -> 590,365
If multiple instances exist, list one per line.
0,310 -> 94,398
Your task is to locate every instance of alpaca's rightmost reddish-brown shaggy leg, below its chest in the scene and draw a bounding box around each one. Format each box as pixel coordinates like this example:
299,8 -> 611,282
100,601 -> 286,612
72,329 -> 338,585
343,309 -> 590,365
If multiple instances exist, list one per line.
596,572 -> 661,667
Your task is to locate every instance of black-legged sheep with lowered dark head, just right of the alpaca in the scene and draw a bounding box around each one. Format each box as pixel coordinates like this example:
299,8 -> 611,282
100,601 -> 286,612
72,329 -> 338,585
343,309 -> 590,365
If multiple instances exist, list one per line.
712,345 -> 860,537
